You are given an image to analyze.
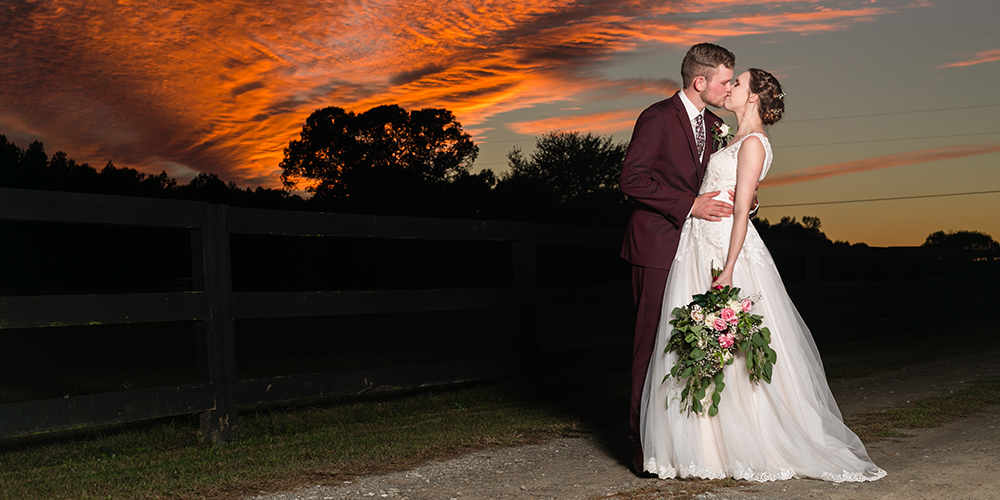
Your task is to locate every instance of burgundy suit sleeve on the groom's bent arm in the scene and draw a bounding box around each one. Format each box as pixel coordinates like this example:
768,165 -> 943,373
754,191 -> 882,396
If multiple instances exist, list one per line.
618,108 -> 695,227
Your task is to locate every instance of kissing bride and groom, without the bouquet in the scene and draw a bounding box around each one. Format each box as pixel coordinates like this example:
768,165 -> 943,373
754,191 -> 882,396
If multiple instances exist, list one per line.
620,43 -> 886,482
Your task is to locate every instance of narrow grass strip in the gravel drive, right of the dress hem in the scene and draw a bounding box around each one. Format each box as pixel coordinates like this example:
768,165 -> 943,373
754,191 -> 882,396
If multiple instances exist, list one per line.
849,379 -> 1000,442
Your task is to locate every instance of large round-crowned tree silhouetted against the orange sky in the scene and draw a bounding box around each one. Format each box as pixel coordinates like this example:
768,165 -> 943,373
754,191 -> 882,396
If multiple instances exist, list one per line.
280,105 -> 479,213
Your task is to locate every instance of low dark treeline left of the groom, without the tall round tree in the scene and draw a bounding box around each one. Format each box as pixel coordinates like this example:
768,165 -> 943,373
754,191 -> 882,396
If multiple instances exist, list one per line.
0,132 -> 630,228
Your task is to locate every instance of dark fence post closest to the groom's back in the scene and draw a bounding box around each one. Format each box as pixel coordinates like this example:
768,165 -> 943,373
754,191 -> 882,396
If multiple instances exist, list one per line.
513,222 -> 539,391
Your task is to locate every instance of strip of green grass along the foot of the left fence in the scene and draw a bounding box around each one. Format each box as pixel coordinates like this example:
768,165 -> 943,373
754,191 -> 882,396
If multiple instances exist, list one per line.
0,384 -> 582,500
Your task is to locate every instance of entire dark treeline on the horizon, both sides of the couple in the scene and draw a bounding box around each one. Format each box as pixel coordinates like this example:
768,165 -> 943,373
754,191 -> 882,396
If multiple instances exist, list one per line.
0,100 -> 996,249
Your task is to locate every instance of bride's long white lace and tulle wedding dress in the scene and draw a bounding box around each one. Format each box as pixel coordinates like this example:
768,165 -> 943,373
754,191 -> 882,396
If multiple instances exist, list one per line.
639,134 -> 885,482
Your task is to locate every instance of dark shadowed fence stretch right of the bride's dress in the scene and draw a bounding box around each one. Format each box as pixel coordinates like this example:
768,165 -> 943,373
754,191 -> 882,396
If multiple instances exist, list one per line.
767,241 -> 1000,339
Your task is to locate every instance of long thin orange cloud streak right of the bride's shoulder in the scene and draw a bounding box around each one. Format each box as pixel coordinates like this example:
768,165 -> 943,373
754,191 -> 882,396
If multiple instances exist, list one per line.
760,144 -> 1000,188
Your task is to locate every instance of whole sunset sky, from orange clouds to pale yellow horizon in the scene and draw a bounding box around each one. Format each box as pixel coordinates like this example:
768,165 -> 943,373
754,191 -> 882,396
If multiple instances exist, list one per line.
0,0 -> 1000,246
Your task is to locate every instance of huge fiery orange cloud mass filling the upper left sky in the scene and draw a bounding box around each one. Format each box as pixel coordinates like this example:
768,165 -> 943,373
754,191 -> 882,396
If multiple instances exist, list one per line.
0,0 -> 916,186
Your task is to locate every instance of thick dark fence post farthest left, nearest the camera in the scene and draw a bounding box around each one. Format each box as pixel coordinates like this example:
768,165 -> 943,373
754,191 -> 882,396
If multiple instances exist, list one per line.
191,205 -> 238,444
